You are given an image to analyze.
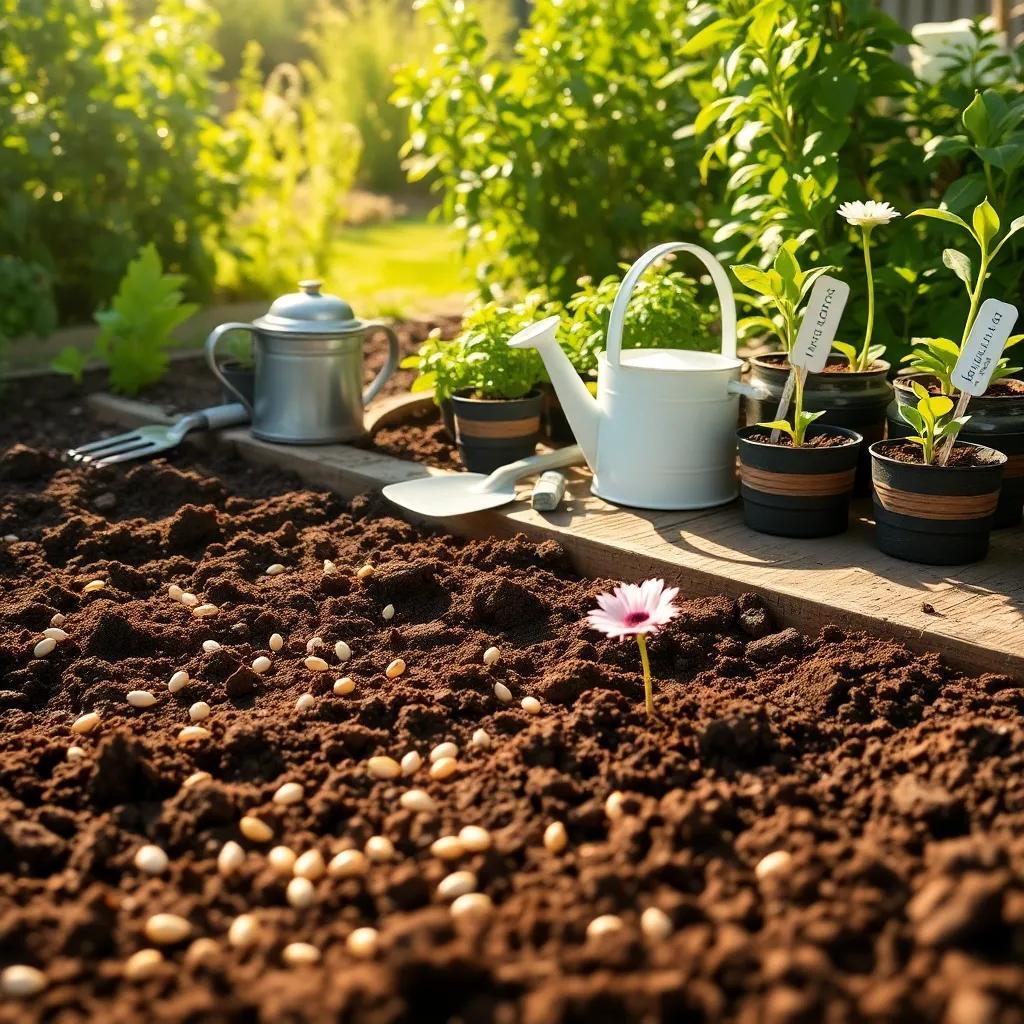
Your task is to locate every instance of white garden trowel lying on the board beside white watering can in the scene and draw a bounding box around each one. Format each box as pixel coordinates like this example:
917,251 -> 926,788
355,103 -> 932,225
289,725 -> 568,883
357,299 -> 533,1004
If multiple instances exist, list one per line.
384,444 -> 584,518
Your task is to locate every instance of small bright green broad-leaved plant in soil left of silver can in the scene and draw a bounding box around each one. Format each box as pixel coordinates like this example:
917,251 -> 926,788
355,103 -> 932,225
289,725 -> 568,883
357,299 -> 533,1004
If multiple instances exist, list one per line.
52,245 -> 197,394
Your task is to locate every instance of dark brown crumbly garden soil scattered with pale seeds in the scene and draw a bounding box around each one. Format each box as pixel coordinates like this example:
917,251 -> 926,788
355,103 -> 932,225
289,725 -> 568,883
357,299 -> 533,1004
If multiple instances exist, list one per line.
0,364 -> 1024,1024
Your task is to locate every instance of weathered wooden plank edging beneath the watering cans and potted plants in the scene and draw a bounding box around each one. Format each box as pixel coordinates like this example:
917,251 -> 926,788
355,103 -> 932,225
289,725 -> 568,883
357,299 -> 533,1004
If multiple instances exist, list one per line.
92,395 -> 1024,677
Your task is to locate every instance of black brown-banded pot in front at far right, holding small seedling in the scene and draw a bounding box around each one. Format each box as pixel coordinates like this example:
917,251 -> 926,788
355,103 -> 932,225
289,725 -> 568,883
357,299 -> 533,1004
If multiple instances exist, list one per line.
870,438 -> 1007,565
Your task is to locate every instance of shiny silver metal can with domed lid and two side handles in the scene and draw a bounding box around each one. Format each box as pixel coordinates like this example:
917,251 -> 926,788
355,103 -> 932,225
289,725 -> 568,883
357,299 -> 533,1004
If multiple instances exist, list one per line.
206,281 -> 398,444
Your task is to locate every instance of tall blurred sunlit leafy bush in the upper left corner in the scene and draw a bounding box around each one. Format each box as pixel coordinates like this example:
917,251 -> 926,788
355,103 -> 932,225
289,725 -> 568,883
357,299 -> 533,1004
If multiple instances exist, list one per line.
0,0 -> 243,321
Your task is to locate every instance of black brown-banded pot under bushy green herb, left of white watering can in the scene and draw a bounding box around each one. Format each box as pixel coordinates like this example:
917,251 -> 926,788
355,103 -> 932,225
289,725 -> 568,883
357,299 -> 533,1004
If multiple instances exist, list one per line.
452,389 -> 544,473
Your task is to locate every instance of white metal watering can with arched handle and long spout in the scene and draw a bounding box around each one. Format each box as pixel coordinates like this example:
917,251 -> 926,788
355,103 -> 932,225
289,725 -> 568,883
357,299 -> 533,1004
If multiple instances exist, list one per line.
509,242 -> 760,509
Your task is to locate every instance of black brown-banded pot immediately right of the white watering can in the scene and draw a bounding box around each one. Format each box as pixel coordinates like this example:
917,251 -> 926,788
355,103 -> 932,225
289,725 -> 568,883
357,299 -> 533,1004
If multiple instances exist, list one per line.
736,423 -> 863,537
